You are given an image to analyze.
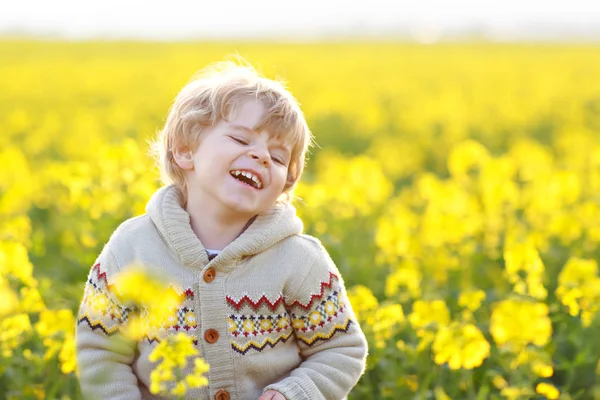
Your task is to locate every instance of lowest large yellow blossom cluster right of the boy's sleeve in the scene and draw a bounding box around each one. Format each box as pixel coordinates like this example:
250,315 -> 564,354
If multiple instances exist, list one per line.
433,322 -> 490,369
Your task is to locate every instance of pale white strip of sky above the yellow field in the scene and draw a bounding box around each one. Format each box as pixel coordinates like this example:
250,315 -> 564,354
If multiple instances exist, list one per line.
0,0 -> 600,42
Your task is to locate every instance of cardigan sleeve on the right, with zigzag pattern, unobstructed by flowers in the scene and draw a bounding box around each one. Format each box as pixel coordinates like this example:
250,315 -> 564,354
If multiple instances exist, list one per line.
264,248 -> 367,400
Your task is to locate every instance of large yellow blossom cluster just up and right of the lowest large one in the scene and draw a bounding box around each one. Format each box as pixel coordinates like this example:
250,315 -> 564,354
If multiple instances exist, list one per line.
490,299 -> 552,349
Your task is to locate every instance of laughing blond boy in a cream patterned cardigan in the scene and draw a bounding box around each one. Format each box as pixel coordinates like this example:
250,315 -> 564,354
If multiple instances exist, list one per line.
77,62 -> 367,400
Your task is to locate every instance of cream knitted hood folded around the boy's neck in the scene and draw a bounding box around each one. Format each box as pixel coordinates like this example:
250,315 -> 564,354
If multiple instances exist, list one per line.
146,185 -> 303,268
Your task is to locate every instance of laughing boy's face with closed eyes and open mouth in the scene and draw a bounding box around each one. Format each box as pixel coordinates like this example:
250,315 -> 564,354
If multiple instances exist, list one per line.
180,99 -> 291,218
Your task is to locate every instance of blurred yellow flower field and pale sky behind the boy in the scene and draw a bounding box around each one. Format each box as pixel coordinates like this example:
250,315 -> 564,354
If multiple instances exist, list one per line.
0,0 -> 600,400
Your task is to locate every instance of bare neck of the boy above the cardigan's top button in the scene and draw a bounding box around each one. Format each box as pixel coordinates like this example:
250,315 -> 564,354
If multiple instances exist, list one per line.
186,197 -> 252,250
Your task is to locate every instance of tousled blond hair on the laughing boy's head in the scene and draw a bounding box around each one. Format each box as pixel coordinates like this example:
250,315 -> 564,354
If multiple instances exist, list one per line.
150,58 -> 312,202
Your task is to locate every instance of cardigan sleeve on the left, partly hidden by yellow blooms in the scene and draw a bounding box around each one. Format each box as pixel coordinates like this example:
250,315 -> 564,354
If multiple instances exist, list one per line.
76,242 -> 142,400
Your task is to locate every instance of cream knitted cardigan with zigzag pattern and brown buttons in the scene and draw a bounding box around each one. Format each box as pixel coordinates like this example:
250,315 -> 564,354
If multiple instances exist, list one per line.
76,186 -> 367,400
